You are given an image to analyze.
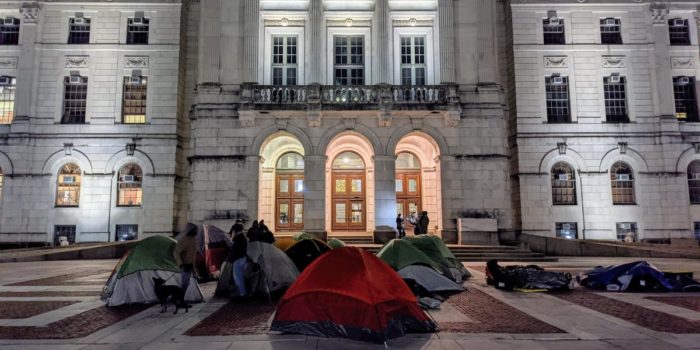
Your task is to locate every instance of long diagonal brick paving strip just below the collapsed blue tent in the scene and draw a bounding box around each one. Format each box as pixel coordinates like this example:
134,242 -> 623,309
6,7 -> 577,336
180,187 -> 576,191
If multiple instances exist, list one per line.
551,290 -> 700,334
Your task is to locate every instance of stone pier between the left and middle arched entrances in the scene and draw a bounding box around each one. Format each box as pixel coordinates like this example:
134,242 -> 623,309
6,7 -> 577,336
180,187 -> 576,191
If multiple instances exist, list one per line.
304,155 -> 326,236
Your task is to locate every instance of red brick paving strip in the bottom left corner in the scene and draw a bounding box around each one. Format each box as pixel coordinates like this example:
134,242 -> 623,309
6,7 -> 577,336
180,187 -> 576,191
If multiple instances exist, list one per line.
0,305 -> 149,339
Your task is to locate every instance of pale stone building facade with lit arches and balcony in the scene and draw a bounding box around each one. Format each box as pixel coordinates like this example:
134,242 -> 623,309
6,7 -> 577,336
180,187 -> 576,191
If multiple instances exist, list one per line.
0,0 -> 700,242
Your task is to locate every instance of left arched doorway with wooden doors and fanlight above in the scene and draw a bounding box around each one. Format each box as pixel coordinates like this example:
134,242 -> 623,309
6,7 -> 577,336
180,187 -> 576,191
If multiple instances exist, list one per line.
275,152 -> 304,231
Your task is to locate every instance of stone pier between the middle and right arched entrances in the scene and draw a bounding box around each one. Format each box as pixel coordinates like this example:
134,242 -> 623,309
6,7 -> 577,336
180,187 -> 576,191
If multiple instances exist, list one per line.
374,156 -> 396,237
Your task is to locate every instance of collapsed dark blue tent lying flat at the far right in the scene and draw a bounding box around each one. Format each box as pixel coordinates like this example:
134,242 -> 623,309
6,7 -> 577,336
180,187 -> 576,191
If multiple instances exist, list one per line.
576,261 -> 700,292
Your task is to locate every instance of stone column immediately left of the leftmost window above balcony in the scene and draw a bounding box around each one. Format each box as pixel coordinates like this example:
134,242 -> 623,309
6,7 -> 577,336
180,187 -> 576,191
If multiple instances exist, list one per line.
243,0 -> 261,83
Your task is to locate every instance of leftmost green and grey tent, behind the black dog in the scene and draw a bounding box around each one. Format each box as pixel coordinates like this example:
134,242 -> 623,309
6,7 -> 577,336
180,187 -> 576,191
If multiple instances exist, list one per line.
102,236 -> 204,306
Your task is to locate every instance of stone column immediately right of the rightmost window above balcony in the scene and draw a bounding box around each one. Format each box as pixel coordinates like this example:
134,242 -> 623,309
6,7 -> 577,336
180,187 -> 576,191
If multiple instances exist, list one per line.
438,0 -> 455,83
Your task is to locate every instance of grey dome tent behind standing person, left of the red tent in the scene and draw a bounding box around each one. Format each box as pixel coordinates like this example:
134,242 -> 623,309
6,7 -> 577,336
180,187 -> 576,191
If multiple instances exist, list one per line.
216,241 -> 299,295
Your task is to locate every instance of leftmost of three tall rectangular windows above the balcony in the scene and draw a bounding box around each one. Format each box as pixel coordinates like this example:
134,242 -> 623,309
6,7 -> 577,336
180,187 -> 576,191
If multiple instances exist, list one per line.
272,36 -> 298,85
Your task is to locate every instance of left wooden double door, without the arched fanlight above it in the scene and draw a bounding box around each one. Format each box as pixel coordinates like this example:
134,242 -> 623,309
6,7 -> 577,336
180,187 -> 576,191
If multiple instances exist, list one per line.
275,173 -> 304,231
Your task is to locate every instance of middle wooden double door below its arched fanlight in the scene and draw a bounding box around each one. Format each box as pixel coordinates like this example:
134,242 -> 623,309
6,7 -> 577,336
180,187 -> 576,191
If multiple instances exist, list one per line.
331,171 -> 367,231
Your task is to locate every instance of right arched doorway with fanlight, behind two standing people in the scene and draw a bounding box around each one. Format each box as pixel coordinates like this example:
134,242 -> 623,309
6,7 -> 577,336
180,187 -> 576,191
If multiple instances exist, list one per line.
396,152 -> 423,229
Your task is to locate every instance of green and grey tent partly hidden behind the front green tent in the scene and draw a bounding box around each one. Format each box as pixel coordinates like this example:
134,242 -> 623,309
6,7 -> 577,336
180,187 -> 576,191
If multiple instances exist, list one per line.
402,235 -> 472,283
